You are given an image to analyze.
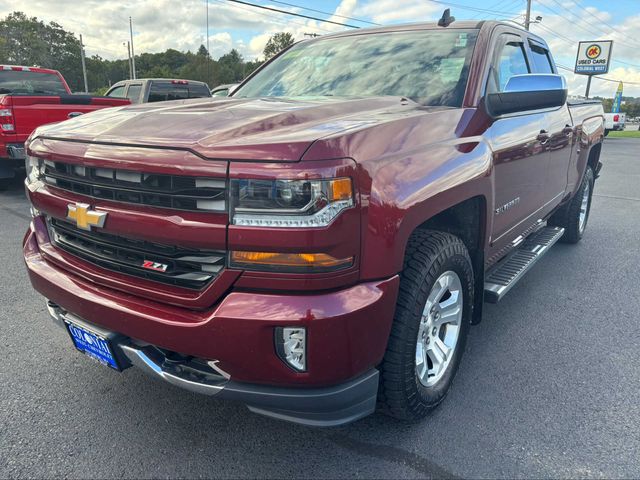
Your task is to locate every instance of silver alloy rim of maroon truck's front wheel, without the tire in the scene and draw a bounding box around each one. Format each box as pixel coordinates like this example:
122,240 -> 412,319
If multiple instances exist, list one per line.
415,271 -> 464,387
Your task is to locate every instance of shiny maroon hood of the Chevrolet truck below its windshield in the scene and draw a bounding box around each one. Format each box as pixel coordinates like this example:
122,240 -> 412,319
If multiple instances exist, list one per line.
33,97 -> 436,161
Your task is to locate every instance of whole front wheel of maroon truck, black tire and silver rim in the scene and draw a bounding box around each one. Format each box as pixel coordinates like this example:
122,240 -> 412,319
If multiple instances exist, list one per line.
378,230 -> 473,420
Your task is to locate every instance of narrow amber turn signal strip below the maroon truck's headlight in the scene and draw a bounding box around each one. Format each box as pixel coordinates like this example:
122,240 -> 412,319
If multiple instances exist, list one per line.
231,251 -> 353,271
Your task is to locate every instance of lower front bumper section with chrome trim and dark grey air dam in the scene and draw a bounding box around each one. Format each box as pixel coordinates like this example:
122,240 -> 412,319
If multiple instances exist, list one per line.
47,302 -> 379,427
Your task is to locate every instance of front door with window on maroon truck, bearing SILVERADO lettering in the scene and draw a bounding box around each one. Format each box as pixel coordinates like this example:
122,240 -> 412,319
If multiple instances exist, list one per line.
486,33 -> 548,249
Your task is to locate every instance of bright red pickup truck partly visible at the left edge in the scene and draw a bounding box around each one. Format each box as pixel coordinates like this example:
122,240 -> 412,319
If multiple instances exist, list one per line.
0,65 -> 130,188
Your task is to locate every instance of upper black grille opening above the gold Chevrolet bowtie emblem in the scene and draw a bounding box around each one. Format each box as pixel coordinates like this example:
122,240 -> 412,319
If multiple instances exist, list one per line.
44,160 -> 226,212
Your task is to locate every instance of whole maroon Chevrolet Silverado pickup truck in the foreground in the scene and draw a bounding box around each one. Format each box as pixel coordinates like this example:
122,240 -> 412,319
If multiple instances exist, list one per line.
24,21 -> 604,425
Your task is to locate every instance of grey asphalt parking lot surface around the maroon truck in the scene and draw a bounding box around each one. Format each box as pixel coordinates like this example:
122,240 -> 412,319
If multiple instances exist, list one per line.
0,138 -> 640,478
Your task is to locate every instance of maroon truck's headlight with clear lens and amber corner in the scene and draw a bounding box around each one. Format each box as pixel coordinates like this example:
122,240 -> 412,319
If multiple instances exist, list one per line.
230,178 -> 353,228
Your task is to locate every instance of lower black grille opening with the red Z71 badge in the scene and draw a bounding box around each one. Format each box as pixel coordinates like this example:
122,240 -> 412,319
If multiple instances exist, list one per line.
48,218 -> 226,289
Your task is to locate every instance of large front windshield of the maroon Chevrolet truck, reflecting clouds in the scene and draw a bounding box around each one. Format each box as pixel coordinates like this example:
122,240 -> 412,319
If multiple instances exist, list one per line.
233,30 -> 477,107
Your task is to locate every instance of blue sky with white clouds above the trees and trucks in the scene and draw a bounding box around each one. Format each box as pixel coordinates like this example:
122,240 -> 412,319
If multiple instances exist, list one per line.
5,0 -> 640,96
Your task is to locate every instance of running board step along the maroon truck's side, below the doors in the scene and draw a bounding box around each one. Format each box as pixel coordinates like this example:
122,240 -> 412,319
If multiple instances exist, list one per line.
484,227 -> 564,303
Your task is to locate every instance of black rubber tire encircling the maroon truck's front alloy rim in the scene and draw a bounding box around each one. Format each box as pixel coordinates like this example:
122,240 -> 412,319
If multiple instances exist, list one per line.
378,230 -> 474,421
